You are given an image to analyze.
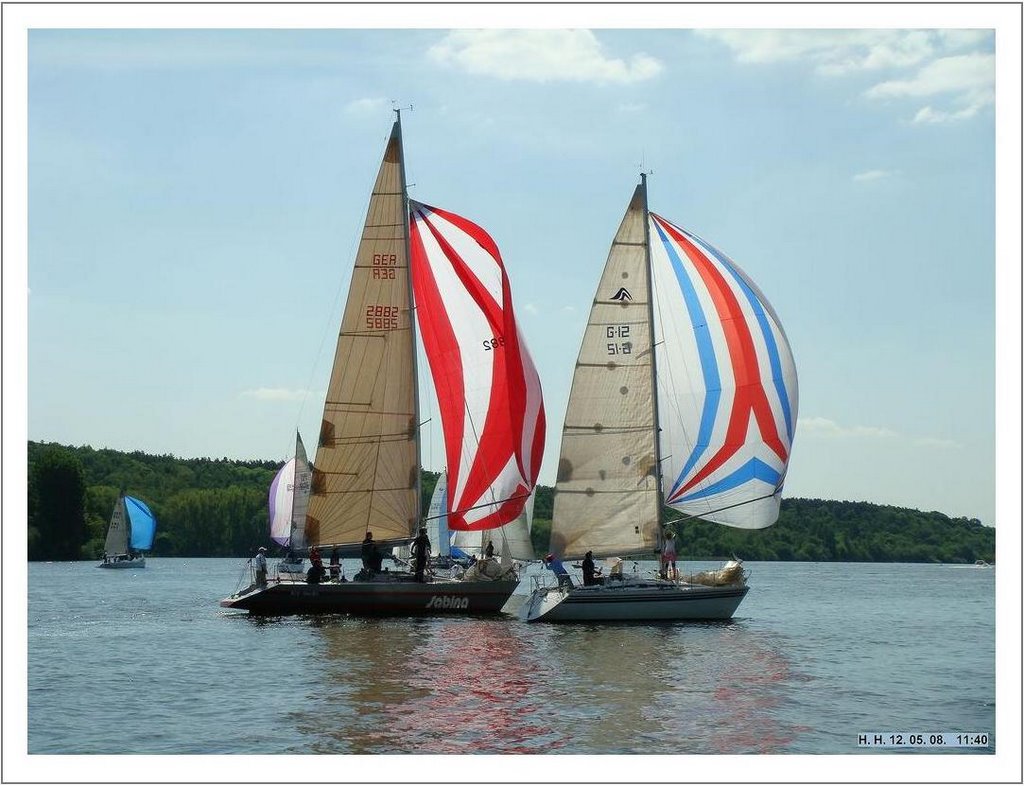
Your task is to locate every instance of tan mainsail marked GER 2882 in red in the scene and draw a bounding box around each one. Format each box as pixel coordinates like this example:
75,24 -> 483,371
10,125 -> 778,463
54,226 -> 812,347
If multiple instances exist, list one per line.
306,122 -> 420,547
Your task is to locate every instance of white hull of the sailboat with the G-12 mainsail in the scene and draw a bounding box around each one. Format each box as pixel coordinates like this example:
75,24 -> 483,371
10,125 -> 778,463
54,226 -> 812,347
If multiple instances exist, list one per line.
522,581 -> 750,622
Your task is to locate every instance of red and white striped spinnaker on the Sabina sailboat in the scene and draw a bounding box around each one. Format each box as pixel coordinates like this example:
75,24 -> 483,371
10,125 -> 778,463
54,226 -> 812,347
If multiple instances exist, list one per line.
410,202 -> 545,530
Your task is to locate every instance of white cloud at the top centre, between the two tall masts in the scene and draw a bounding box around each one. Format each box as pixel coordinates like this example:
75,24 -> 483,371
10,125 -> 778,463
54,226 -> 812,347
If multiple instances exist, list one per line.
427,30 -> 662,84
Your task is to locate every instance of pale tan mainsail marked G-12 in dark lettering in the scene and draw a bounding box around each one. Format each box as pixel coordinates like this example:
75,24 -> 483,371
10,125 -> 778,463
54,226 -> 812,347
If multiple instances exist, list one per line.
551,183 -> 658,558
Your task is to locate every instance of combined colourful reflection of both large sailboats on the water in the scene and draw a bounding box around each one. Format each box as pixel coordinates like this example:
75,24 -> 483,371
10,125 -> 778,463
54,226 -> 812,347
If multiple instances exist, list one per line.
276,617 -> 806,753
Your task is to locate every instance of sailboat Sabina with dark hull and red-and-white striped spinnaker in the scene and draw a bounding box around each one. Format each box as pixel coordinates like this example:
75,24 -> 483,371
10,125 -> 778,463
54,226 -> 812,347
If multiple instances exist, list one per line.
221,114 -> 544,615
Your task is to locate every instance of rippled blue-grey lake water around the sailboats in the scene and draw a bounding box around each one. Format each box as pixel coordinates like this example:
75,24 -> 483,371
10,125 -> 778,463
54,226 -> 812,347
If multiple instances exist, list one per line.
28,558 -> 995,780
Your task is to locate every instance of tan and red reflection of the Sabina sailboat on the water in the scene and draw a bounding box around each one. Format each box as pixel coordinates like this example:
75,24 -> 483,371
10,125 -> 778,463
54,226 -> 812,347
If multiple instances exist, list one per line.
286,617 -> 568,753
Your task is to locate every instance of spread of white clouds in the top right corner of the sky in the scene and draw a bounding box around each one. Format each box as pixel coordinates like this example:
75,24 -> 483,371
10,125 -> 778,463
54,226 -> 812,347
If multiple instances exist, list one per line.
698,30 -> 995,124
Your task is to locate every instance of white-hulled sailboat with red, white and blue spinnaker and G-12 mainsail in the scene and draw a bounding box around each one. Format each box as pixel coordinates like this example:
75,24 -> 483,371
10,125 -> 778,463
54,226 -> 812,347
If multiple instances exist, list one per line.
520,176 -> 797,621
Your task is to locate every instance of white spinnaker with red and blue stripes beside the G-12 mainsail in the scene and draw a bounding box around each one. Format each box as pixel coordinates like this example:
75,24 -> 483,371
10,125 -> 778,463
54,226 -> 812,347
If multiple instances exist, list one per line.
649,213 -> 798,529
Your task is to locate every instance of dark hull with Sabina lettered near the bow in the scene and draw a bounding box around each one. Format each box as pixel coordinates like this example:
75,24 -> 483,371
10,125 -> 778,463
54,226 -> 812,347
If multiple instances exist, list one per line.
220,579 -> 518,616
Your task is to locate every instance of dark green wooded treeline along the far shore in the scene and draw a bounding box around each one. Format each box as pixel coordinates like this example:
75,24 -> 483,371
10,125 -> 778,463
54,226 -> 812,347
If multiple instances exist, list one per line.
28,442 -> 995,563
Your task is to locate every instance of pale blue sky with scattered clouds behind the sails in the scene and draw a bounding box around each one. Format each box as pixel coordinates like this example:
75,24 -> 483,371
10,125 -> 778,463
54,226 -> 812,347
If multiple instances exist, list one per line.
4,6 -> 1020,525
